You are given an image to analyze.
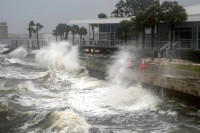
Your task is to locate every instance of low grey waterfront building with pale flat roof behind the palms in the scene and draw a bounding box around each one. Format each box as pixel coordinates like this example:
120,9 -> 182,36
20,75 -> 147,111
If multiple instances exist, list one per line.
69,5 -> 200,51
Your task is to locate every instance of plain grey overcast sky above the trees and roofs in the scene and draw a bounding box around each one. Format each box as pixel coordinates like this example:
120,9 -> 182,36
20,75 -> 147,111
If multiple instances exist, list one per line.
0,0 -> 200,33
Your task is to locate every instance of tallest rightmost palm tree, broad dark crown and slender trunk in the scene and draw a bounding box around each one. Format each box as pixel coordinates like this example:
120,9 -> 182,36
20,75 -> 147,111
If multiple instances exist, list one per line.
161,1 -> 187,61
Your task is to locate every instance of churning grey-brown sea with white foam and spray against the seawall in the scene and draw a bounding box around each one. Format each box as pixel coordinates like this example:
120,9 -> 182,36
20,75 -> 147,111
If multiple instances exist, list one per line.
0,43 -> 200,133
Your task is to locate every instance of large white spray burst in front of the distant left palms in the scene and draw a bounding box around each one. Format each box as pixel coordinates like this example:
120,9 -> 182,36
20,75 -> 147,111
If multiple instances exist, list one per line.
35,42 -> 80,72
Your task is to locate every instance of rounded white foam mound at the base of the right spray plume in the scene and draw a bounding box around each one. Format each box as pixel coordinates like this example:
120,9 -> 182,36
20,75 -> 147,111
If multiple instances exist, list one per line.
106,85 -> 159,110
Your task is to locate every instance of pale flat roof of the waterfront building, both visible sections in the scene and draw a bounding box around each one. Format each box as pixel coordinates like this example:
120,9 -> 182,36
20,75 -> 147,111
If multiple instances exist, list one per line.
69,5 -> 200,24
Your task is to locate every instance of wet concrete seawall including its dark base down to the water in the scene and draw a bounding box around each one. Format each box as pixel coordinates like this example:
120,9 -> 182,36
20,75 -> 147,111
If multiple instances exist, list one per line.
80,59 -> 200,107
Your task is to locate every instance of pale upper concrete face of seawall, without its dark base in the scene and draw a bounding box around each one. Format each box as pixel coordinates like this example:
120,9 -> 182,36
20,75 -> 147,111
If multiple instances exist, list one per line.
80,59 -> 200,98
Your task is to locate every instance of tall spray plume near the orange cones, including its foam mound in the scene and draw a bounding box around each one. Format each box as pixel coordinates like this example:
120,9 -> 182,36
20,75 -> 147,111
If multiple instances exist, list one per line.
106,49 -> 159,110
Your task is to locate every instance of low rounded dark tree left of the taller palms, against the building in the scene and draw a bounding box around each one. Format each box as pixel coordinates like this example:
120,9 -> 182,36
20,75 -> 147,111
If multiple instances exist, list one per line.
116,20 -> 131,43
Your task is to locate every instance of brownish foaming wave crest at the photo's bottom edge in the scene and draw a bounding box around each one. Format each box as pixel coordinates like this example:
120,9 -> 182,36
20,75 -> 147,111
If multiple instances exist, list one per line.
21,110 -> 89,133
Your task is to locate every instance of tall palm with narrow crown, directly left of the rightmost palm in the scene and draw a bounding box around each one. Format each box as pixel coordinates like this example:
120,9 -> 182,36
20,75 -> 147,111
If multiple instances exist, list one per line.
146,4 -> 162,59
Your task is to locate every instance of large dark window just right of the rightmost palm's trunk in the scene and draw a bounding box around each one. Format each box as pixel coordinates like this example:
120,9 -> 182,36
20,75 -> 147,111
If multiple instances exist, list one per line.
175,27 -> 192,48
